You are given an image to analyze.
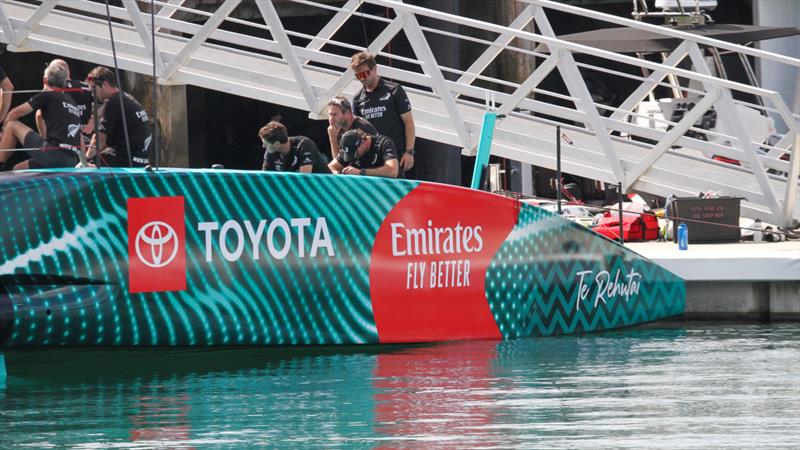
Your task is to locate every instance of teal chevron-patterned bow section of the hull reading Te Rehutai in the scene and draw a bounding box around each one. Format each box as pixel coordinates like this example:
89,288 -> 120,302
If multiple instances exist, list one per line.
486,205 -> 686,337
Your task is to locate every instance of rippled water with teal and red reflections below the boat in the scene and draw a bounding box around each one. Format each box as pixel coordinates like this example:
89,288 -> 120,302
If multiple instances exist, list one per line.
0,322 -> 800,449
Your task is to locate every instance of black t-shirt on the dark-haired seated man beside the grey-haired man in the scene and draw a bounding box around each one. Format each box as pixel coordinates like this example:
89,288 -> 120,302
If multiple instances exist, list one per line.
97,93 -> 153,167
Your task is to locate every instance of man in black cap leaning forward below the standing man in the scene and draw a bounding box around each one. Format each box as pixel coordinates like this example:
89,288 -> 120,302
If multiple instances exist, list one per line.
328,130 -> 398,178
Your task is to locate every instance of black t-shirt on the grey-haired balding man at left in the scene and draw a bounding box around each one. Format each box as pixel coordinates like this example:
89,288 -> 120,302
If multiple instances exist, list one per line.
28,91 -> 81,147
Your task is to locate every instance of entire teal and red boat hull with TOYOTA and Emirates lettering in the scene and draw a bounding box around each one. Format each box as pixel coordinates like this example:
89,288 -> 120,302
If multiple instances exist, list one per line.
0,170 -> 685,346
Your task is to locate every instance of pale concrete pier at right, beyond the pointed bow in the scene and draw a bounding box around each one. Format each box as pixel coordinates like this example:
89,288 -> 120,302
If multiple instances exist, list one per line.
625,241 -> 800,320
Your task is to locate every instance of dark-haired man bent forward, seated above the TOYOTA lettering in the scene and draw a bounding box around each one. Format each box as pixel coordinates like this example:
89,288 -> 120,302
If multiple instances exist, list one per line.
258,121 -> 331,173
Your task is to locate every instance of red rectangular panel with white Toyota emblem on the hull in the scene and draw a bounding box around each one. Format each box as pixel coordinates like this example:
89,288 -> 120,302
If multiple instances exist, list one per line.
128,197 -> 186,293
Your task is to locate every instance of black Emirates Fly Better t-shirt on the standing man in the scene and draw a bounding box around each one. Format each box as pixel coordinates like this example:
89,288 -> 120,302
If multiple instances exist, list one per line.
353,77 -> 411,156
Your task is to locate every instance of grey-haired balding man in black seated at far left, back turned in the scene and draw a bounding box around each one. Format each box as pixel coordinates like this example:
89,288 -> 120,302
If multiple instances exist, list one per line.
0,64 -> 81,170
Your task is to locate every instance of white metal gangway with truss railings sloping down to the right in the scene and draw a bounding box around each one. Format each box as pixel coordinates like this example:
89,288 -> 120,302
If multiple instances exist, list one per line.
0,0 -> 800,225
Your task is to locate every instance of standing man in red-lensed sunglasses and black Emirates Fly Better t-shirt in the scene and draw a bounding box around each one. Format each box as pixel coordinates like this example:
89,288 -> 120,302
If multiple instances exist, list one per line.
350,52 -> 416,178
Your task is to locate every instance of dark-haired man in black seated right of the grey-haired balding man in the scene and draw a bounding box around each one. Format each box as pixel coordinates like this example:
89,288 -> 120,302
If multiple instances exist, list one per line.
86,66 -> 153,167
